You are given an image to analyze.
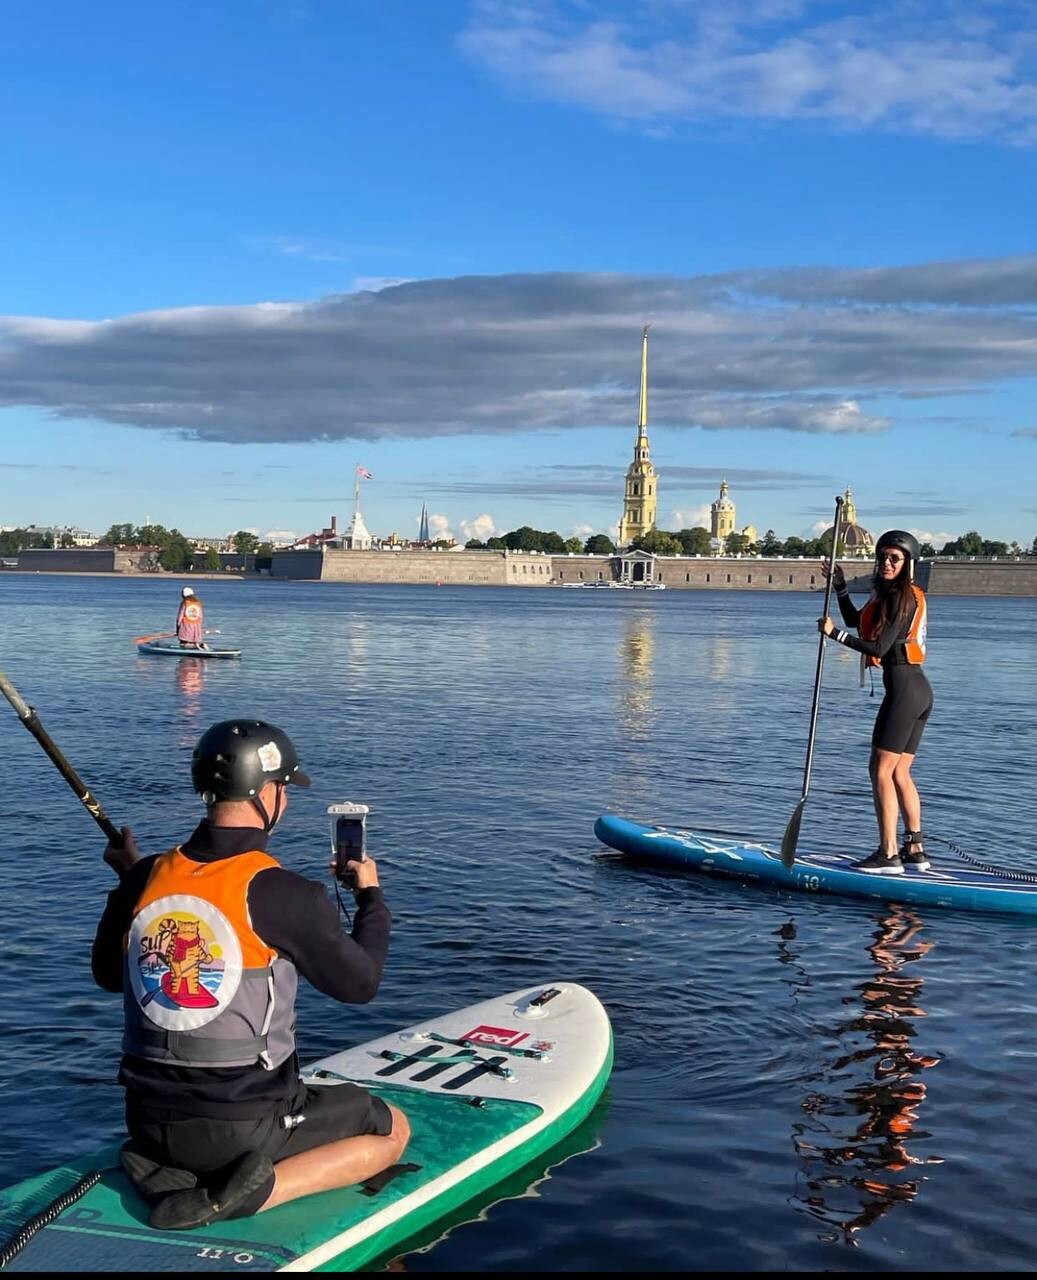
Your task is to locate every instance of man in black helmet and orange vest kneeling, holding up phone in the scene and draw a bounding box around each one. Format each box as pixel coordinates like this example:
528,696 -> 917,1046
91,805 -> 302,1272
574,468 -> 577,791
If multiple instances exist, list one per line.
92,719 -> 410,1229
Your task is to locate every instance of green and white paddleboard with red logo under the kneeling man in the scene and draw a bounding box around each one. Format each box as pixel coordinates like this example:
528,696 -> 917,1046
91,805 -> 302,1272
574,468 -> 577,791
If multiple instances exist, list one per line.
0,982 -> 612,1274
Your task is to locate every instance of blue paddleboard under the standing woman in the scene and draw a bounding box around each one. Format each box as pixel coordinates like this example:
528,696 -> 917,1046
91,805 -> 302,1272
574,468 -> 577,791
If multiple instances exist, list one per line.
594,814 -> 1037,915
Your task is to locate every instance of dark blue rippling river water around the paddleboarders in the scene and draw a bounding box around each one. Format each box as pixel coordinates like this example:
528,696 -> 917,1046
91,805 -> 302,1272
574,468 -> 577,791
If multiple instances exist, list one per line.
0,575 -> 1037,1271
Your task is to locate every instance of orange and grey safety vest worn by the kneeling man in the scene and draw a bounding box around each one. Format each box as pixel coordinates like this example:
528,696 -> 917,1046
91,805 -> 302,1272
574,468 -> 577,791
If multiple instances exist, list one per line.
123,849 -> 298,1070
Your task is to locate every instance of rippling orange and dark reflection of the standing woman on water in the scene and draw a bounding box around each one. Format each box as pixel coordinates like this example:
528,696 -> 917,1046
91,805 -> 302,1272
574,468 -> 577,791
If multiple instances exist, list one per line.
778,906 -> 942,1244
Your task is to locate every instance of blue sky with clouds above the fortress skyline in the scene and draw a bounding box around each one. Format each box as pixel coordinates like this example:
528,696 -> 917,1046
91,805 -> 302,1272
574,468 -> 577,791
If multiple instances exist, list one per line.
0,0 -> 1037,545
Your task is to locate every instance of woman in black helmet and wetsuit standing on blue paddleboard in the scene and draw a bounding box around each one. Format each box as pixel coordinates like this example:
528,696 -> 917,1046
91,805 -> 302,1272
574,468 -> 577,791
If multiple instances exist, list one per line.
818,529 -> 932,876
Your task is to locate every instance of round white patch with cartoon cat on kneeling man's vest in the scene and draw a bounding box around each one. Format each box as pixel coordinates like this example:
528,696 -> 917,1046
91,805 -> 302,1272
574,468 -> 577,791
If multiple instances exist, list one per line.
128,893 -> 242,1032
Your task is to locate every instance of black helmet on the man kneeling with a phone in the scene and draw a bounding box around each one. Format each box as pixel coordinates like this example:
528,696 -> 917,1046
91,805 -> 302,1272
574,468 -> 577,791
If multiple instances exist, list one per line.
191,719 -> 310,803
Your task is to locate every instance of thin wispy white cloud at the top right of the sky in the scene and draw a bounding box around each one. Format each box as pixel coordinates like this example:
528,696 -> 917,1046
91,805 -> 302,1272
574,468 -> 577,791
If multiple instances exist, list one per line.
461,0 -> 1037,145
